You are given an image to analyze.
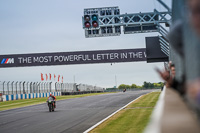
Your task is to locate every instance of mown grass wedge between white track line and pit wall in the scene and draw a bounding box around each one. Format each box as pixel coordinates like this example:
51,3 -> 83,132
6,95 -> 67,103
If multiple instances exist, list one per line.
90,92 -> 160,133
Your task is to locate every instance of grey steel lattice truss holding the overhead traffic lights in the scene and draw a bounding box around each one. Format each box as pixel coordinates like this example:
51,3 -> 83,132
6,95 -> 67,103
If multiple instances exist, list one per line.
99,10 -> 171,27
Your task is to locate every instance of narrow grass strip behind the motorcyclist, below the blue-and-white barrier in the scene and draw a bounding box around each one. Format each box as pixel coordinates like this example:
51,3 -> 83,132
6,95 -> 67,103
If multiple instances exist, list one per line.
0,93 -> 111,111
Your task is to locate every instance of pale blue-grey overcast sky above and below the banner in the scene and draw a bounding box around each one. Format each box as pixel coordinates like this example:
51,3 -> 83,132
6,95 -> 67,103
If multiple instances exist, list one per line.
0,0 -> 171,87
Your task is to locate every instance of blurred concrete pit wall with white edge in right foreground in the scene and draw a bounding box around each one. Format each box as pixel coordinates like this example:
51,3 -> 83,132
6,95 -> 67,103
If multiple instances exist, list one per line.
144,88 -> 200,133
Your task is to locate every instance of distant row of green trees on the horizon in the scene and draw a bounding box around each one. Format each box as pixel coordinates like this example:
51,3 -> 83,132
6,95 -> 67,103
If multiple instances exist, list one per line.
118,81 -> 164,89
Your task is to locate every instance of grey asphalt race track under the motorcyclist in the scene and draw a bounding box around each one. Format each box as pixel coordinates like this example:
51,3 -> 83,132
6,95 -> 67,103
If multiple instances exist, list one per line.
0,90 -> 155,133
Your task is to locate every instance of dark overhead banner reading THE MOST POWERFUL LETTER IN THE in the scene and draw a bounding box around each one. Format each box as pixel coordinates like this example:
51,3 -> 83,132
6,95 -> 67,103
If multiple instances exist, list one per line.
0,48 -> 146,67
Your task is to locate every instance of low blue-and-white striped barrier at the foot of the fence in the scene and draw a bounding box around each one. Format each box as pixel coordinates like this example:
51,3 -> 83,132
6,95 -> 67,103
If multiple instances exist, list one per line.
2,92 -> 61,101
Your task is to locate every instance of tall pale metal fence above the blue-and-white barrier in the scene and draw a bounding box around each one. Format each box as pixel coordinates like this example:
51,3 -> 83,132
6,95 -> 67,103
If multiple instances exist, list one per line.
0,81 -> 103,95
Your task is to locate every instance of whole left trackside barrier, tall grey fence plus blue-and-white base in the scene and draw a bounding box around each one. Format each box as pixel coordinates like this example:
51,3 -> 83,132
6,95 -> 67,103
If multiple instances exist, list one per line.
0,81 -> 104,101
